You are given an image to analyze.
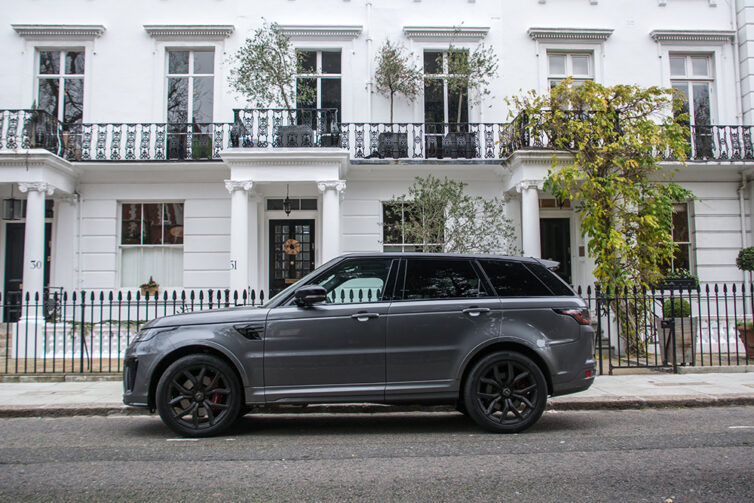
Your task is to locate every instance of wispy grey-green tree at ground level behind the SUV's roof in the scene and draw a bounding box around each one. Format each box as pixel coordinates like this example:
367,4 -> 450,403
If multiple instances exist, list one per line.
384,175 -> 517,254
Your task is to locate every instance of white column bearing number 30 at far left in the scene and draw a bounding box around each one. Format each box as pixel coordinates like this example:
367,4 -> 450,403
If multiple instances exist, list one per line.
18,182 -> 55,303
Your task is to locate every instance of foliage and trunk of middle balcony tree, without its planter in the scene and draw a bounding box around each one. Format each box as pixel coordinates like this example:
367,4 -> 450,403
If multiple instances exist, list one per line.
374,40 -> 422,122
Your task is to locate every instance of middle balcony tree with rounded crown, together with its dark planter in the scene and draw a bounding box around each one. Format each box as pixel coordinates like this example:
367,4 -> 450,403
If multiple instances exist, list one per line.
374,40 -> 422,158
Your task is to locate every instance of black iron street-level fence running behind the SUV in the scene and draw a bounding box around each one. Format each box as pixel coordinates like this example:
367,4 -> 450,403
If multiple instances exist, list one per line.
0,284 -> 754,374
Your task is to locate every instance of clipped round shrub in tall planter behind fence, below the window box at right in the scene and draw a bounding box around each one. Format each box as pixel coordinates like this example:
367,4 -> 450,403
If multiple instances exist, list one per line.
657,297 -> 699,365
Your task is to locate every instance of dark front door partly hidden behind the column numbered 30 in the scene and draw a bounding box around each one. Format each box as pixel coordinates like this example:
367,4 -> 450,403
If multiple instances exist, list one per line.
3,222 -> 52,322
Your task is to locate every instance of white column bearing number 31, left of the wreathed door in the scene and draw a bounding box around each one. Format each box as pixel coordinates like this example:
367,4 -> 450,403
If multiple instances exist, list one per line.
225,180 -> 257,295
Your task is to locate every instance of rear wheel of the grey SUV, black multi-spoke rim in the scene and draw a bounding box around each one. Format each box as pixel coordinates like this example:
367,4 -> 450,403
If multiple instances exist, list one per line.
464,352 -> 547,433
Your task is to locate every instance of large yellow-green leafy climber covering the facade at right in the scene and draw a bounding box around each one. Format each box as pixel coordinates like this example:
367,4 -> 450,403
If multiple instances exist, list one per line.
509,79 -> 693,288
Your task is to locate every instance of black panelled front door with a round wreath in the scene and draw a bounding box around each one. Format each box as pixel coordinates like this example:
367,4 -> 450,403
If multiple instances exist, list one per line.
270,220 -> 314,296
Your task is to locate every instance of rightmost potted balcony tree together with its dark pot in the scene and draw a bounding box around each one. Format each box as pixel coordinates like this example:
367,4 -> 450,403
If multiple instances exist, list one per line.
438,43 -> 498,159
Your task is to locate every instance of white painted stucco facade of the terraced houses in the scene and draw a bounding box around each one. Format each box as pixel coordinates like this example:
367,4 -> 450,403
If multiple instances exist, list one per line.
0,0 -> 754,300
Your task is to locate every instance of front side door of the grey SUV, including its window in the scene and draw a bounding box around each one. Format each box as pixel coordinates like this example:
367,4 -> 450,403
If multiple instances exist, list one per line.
264,258 -> 393,402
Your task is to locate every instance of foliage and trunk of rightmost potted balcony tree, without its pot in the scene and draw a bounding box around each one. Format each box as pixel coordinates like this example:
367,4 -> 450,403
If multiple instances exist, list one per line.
438,43 -> 498,123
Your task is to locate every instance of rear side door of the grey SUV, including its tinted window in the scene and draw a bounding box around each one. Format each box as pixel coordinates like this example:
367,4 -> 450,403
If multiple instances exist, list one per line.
385,257 -> 501,401
